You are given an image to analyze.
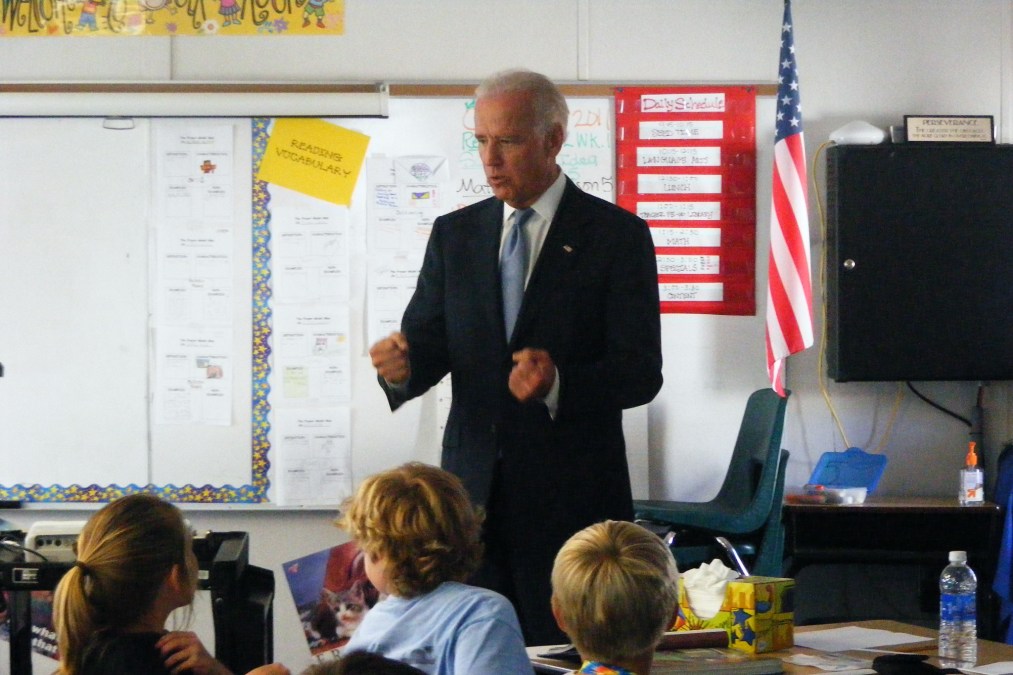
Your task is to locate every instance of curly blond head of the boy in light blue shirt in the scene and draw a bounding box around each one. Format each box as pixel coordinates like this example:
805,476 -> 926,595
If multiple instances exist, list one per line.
338,462 -> 482,598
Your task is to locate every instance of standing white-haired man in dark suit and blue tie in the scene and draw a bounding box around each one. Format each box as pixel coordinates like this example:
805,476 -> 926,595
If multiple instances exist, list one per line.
370,66 -> 661,645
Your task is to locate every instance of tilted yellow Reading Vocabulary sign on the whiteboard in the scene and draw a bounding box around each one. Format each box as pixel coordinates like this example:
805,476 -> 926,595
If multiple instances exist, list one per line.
257,118 -> 370,206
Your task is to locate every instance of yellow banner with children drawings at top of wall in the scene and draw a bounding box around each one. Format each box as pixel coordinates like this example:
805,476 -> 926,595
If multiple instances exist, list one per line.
0,0 -> 344,38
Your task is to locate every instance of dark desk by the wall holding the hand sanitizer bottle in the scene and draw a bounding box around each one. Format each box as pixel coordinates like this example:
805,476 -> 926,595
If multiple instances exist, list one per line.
783,497 -> 1002,638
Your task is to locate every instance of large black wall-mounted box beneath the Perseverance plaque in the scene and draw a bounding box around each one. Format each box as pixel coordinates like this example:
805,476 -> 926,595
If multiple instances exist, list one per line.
826,143 -> 1013,382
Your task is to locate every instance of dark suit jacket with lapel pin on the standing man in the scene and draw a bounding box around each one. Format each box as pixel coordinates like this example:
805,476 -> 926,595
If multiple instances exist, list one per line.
381,174 -> 661,543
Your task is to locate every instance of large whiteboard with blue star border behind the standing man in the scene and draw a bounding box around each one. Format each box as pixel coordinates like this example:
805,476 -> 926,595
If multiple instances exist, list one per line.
0,97 -> 628,503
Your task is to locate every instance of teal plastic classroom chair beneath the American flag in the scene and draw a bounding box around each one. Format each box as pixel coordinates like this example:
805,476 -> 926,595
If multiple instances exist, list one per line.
633,389 -> 790,577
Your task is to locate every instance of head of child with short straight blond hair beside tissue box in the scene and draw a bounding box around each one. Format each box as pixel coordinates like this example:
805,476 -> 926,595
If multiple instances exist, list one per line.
552,520 -> 679,663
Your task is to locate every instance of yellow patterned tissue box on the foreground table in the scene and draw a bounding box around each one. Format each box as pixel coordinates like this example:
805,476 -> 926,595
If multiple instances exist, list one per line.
673,577 -> 795,654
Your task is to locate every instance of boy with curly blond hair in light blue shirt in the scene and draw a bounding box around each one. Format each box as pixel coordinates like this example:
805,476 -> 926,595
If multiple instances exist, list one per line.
338,462 -> 533,675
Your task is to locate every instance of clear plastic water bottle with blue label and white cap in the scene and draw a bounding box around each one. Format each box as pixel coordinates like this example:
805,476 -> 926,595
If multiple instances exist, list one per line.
939,550 -> 978,668
